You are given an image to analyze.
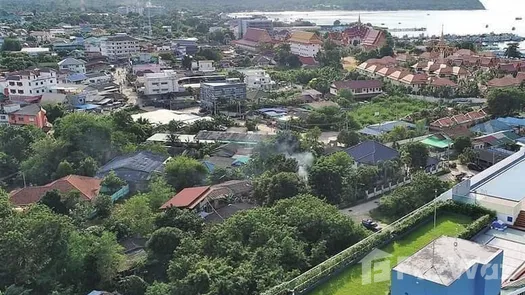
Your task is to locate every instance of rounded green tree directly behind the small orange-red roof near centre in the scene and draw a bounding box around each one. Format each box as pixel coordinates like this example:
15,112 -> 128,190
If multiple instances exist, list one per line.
165,156 -> 208,191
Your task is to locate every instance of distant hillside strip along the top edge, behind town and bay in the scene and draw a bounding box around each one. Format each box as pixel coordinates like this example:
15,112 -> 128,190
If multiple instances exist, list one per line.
0,0 -> 485,12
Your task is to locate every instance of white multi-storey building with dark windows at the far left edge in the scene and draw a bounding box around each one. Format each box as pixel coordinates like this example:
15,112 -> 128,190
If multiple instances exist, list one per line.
6,69 -> 57,99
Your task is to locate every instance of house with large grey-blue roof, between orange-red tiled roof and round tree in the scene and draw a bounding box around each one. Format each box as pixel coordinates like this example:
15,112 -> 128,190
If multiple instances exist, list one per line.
96,151 -> 168,191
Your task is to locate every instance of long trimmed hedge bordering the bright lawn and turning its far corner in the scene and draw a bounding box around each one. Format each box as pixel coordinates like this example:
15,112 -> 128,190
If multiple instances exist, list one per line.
263,200 -> 496,295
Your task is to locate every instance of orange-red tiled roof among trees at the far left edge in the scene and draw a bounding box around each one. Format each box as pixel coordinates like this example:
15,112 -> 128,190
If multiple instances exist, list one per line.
9,175 -> 102,206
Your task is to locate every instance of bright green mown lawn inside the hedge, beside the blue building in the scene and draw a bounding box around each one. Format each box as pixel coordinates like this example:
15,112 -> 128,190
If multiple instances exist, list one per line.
310,214 -> 472,295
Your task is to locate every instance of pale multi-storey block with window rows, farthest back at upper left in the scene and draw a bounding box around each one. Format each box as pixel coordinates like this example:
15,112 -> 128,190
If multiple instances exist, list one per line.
100,33 -> 139,60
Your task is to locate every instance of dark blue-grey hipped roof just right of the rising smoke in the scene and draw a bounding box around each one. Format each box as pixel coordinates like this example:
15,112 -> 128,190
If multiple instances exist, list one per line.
345,140 -> 399,165
